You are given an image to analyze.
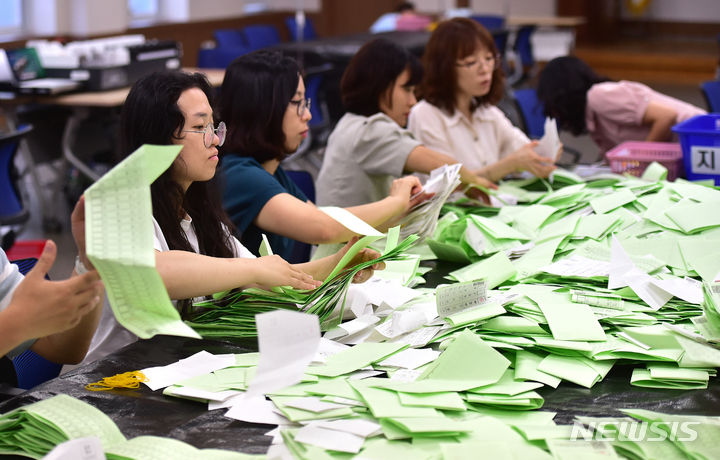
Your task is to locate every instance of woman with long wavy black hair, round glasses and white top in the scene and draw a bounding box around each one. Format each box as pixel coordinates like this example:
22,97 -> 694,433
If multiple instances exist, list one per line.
79,72 -> 379,362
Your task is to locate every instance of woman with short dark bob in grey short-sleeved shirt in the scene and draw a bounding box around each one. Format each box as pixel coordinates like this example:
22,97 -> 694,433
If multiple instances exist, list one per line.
317,38 -> 494,213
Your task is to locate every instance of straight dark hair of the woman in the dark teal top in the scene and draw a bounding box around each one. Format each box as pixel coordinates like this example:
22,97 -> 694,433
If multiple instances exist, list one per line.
218,51 -> 300,163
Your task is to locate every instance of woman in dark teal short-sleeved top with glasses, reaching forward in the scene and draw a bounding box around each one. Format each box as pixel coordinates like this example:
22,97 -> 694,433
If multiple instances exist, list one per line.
219,51 -> 426,258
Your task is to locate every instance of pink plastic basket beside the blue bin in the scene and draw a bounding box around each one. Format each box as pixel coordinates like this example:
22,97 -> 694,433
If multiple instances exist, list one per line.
605,141 -> 683,181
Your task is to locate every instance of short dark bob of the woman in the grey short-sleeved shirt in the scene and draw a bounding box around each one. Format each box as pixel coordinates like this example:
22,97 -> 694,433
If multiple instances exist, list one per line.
340,38 -> 422,117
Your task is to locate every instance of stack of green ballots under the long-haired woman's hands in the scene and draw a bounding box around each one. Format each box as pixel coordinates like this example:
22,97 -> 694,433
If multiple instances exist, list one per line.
186,233 -> 417,337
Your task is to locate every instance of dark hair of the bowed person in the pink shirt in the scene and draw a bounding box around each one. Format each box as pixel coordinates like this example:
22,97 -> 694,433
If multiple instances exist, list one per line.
537,56 -> 609,136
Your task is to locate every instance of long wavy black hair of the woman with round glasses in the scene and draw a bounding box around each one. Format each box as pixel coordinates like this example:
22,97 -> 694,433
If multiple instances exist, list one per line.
120,71 -> 234,257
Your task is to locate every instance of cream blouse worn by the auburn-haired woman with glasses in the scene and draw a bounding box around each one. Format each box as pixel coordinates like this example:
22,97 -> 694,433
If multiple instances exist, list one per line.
408,101 -> 530,170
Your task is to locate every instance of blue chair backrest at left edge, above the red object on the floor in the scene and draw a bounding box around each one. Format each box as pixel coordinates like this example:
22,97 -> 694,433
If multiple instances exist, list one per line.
0,126 -> 32,225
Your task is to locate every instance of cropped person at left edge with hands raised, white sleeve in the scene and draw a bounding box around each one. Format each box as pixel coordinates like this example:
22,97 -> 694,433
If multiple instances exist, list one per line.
0,198 -> 103,374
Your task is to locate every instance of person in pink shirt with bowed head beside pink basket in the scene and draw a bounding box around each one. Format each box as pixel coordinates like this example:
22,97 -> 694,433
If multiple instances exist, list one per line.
537,56 -> 706,152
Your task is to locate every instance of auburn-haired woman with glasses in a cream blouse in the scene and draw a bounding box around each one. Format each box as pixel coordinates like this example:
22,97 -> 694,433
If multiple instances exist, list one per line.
408,18 -> 555,182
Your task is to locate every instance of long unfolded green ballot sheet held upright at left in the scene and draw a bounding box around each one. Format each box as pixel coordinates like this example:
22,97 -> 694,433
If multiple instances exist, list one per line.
85,145 -> 200,339
